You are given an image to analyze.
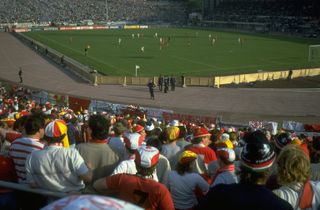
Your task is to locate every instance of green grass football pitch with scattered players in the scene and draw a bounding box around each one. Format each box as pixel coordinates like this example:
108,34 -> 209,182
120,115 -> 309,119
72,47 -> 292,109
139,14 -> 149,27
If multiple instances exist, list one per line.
26,28 -> 320,76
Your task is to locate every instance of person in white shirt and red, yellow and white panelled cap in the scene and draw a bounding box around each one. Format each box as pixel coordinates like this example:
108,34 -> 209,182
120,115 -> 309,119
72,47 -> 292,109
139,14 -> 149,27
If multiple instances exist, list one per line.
26,120 -> 92,192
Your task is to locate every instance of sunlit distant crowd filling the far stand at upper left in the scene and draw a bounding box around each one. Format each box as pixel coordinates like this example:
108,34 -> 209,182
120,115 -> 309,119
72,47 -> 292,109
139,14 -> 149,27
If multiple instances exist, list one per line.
0,0 -> 187,23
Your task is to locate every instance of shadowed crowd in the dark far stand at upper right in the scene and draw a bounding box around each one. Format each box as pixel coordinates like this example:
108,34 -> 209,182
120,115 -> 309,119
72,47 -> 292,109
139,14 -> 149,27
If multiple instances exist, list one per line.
205,0 -> 320,36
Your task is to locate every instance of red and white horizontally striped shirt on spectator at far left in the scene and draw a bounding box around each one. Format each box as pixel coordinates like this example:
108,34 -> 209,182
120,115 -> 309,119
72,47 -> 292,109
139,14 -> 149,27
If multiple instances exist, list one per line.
9,137 -> 44,183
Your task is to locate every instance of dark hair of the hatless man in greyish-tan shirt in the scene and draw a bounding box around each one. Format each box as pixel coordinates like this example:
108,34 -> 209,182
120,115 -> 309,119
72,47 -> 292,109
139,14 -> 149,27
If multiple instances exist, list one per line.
89,115 -> 110,140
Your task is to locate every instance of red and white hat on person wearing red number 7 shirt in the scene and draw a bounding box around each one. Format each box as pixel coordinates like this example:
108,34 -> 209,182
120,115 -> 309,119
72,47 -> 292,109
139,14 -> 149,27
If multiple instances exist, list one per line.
135,146 -> 160,168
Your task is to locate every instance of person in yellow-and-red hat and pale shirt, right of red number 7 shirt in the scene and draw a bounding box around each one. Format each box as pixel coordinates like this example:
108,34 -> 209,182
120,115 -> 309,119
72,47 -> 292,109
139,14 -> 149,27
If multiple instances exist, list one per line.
167,150 -> 209,209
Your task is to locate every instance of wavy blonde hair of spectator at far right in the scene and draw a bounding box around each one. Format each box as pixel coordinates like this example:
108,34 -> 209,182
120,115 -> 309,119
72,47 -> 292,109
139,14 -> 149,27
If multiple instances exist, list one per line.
277,144 -> 310,185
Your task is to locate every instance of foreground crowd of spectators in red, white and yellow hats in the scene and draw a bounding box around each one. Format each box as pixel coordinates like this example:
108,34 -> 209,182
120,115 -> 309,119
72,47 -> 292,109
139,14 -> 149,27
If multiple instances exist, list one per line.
0,84 -> 320,210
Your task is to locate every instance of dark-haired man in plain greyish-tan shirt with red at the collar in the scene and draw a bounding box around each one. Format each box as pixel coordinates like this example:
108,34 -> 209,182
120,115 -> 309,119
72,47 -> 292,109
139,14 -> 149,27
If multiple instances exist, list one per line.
76,115 -> 119,192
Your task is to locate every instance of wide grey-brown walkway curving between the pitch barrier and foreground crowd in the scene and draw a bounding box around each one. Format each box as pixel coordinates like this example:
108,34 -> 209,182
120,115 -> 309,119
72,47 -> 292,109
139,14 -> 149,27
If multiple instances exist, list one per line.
0,32 -> 320,123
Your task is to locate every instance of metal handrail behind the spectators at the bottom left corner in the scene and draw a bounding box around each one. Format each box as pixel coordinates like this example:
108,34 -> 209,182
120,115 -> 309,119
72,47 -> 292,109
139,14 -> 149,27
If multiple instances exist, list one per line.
0,181 -> 68,198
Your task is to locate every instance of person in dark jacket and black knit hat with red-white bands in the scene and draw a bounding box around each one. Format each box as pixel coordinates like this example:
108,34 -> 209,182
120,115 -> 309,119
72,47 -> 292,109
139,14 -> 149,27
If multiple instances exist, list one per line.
196,131 -> 292,210
